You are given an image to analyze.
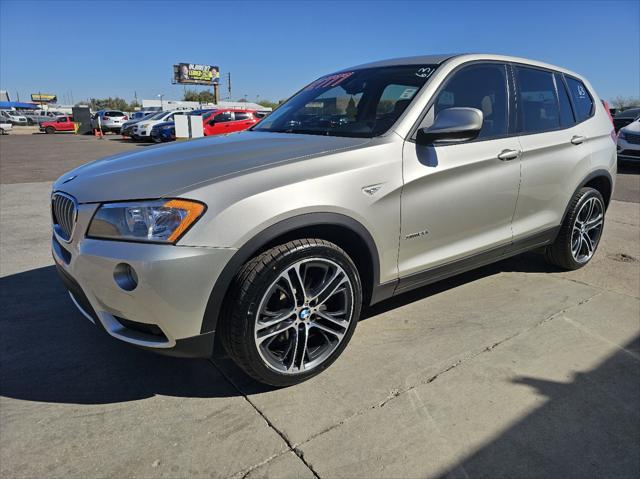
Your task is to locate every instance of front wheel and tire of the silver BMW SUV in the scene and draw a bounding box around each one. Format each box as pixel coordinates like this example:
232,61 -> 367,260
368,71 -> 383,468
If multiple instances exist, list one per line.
219,239 -> 362,386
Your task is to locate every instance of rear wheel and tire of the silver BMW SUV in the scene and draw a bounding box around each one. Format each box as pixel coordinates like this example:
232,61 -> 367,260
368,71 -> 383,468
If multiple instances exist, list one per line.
545,187 -> 605,270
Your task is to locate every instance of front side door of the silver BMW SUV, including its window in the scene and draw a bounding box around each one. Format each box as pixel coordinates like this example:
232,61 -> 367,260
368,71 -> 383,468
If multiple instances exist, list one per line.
398,62 -> 520,290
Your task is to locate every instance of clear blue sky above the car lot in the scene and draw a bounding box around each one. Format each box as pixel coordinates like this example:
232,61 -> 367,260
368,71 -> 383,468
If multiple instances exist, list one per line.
0,0 -> 640,102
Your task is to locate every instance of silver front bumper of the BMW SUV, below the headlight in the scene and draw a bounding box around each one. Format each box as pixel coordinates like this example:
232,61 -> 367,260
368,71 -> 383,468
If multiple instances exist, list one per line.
51,205 -> 235,357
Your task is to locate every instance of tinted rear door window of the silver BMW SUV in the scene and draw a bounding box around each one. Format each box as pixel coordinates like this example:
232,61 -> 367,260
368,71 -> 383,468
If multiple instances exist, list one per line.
516,67 -> 560,133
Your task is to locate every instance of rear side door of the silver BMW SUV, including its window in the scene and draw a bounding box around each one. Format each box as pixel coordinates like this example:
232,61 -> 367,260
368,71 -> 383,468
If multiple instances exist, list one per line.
513,65 -> 591,240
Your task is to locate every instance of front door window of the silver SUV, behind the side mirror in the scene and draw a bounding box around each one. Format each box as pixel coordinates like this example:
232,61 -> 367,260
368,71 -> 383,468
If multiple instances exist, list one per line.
435,64 -> 508,138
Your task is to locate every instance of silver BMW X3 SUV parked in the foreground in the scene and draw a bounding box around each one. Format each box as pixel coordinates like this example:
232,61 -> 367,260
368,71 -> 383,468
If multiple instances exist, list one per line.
52,54 -> 616,386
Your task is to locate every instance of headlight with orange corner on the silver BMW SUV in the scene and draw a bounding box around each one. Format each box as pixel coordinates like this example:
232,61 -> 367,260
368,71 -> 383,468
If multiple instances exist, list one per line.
87,199 -> 206,244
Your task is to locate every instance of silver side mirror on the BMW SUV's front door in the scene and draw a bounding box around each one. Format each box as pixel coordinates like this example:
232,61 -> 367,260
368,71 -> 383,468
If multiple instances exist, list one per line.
416,107 -> 483,146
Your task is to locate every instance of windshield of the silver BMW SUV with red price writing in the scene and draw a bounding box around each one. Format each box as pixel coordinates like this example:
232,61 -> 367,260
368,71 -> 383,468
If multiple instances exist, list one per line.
252,65 -> 437,138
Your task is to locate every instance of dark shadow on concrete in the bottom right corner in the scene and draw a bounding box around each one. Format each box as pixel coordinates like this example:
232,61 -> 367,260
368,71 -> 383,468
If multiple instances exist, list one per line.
439,336 -> 640,479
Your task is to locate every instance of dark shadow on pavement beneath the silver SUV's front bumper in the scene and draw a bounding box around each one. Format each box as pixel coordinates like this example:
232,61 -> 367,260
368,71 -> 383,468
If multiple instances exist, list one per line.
0,266 -> 238,404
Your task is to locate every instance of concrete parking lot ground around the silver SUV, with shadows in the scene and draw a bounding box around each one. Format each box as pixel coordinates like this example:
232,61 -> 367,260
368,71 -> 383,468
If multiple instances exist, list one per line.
0,135 -> 640,478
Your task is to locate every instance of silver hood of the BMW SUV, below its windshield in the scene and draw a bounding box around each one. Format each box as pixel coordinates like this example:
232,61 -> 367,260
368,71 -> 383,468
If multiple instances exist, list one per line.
53,131 -> 371,203
